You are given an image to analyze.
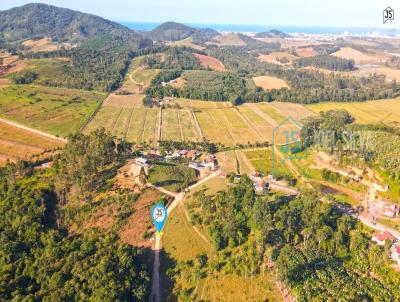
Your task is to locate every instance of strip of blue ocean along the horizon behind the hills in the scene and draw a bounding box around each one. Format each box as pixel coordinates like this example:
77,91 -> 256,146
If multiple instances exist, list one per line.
120,22 -> 400,35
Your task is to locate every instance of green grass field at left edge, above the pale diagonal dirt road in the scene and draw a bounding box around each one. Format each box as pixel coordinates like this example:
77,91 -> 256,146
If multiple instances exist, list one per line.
0,85 -> 106,136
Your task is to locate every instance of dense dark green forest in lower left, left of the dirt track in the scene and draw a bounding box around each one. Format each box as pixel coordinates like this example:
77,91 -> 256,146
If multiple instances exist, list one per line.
0,131 -> 150,301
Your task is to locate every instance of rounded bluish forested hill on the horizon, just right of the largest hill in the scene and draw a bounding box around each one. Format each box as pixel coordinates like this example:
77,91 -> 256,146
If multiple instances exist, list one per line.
146,22 -> 219,43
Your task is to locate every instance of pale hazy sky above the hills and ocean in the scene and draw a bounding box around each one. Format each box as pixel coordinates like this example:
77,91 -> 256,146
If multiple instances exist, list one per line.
0,0 -> 400,28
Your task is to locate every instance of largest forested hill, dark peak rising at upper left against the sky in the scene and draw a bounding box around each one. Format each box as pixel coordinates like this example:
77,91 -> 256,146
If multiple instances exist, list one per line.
0,3 -> 141,42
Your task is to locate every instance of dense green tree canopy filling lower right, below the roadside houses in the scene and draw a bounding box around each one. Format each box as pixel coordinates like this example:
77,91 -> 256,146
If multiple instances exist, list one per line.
184,177 -> 400,301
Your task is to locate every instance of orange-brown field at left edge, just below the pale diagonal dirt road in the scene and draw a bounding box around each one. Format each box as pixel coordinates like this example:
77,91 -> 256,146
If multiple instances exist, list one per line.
0,122 -> 63,164
